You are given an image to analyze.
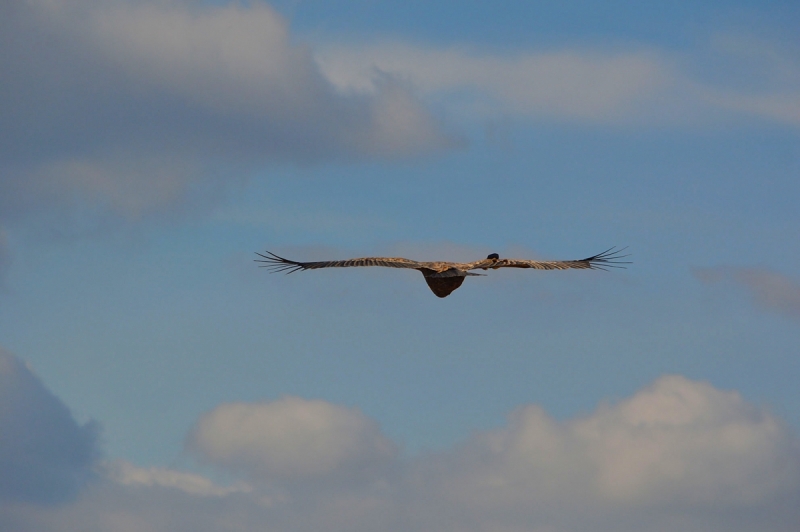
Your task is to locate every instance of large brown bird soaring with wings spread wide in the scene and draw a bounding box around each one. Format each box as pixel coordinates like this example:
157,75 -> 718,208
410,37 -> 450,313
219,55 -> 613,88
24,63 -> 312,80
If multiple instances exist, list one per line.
255,248 -> 630,297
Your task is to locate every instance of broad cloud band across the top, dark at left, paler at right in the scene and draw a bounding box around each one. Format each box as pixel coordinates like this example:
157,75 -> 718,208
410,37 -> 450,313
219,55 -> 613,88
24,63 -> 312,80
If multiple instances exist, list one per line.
0,0 -> 800,227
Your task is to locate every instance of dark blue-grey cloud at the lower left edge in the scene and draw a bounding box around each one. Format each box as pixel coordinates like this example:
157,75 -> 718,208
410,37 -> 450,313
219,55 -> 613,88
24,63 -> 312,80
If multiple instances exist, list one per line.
0,349 -> 98,504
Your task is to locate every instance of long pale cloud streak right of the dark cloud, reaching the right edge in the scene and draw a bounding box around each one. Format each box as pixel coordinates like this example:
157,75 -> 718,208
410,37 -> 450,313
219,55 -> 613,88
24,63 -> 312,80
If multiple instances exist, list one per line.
315,35 -> 800,125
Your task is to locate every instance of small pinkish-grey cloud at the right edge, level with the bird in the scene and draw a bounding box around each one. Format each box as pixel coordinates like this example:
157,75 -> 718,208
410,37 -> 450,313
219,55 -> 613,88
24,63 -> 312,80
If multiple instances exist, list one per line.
694,267 -> 800,319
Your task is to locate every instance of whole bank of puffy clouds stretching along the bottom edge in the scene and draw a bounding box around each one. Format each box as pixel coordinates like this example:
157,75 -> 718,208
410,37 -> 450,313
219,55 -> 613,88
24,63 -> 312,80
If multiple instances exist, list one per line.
6,375 -> 800,532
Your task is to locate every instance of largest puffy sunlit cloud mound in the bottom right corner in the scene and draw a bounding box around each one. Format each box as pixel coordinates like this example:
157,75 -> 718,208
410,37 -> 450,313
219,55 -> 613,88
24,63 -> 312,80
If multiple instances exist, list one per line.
396,376 -> 800,532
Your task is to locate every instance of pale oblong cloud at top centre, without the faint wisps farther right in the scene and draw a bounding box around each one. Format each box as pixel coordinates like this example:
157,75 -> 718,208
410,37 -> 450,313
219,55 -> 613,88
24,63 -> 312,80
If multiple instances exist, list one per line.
316,43 -> 670,121
